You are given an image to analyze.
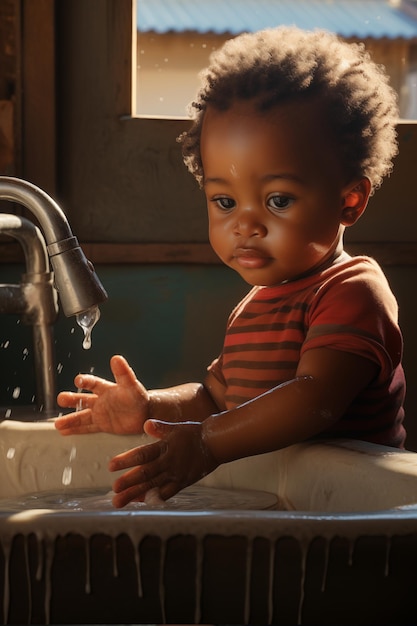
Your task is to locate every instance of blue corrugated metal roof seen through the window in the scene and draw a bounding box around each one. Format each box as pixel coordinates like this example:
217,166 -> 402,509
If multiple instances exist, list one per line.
137,0 -> 417,39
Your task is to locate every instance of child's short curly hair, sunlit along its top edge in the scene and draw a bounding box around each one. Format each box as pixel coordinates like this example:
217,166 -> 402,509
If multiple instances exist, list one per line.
178,26 -> 398,191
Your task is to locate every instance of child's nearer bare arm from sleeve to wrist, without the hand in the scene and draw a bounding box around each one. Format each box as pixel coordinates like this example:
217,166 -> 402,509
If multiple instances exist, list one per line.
203,348 -> 378,463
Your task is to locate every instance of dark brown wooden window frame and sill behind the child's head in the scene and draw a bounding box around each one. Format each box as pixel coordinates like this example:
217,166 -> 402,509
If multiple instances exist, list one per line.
3,0 -> 417,265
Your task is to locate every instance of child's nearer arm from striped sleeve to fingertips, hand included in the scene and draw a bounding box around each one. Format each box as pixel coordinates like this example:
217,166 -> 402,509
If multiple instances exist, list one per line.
110,348 -> 377,507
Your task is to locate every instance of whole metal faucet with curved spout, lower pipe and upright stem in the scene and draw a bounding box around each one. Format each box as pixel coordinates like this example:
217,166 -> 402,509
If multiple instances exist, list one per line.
0,176 -> 107,412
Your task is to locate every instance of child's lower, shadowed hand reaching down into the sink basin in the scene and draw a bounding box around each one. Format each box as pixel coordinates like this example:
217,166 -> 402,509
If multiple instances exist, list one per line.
109,419 -> 218,508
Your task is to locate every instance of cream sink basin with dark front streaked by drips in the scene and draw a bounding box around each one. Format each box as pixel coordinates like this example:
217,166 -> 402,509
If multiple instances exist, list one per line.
0,420 -> 417,624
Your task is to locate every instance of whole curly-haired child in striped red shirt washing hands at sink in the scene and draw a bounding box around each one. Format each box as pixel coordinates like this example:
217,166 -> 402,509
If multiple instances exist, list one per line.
55,27 -> 405,507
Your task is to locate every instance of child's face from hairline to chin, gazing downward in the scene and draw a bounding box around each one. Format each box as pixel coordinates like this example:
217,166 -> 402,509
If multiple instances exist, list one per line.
201,102 -> 356,285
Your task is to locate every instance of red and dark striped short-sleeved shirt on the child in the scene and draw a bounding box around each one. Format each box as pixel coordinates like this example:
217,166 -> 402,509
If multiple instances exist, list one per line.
208,255 -> 405,447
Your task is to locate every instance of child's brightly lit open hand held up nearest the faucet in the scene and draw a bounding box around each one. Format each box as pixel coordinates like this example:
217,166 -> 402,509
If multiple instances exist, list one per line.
55,356 -> 149,435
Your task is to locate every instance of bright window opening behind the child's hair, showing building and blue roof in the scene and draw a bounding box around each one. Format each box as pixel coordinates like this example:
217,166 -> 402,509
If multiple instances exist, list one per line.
134,0 -> 417,119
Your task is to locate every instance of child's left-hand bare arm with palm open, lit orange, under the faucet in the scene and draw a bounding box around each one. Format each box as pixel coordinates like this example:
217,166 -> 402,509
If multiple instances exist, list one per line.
55,355 -> 218,435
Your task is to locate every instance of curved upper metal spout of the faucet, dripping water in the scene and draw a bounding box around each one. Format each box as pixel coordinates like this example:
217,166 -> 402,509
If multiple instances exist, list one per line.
0,176 -> 107,317
